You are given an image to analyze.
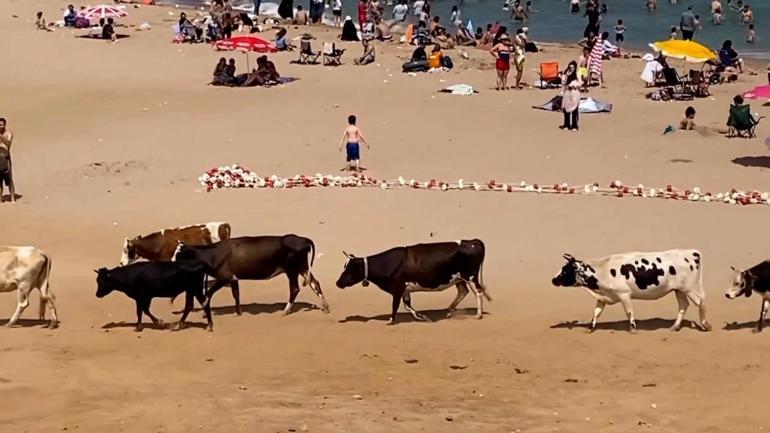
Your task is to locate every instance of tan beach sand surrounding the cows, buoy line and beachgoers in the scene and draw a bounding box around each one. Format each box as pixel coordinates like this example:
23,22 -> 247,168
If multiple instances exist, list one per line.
0,0 -> 770,433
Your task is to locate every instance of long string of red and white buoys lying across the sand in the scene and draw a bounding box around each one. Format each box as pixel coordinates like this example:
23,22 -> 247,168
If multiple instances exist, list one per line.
198,164 -> 770,205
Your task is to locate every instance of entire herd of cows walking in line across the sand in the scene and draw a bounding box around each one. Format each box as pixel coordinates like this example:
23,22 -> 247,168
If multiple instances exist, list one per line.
0,222 -> 770,332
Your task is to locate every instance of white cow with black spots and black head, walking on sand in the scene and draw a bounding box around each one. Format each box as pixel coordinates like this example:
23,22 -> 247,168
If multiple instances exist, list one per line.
551,250 -> 711,332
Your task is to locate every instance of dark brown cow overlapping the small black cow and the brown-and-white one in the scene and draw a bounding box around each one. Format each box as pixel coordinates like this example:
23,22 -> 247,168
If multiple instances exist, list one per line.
173,235 -> 329,315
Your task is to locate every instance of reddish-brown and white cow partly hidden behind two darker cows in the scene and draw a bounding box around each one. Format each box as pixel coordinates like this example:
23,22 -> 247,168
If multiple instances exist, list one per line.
120,222 -> 231,266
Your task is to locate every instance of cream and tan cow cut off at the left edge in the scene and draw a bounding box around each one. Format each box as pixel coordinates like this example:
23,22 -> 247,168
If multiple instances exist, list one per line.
0,247 -> 59,329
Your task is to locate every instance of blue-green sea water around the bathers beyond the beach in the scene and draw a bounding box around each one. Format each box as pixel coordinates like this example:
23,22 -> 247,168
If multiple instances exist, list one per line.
160,0 -> 770,59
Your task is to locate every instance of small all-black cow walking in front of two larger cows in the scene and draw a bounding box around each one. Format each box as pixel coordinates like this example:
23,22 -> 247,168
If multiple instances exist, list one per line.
94,262 -> 214,332
